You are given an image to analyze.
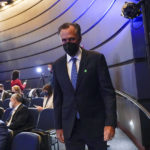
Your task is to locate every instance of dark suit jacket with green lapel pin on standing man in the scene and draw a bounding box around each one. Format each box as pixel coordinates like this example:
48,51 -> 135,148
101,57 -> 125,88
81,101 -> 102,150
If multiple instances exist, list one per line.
54,50 -> 116,138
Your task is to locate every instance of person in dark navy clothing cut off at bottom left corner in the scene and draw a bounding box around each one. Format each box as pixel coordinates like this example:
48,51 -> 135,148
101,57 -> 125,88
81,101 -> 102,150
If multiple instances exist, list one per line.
0,120 -> 8,150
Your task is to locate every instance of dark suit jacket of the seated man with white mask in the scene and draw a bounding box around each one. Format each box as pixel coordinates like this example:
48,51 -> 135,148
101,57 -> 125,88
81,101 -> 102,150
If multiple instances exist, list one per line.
8,104 -> 33,134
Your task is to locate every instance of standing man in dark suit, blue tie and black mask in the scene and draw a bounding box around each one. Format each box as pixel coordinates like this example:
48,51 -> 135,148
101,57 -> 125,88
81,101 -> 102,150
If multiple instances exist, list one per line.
53,23 -> 116,150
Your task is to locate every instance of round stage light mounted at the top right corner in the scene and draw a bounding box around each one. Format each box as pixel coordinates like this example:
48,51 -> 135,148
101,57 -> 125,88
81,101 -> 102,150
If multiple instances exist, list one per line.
121,0 -> 143,19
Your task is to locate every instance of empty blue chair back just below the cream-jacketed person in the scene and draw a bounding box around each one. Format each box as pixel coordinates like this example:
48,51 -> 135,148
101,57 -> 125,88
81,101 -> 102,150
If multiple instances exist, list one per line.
36,108 -> 55,131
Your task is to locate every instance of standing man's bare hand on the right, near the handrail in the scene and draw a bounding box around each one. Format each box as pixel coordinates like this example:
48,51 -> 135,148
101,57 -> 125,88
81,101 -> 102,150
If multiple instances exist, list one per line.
104,126 -> 115,141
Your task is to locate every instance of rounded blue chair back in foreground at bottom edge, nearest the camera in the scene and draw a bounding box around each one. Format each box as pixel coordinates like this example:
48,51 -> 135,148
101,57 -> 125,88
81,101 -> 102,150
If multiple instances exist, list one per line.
11,132 -> 41,150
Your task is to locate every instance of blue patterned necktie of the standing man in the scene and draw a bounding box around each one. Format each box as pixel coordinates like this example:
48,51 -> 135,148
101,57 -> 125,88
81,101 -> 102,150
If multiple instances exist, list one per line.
71,57 -> 77,89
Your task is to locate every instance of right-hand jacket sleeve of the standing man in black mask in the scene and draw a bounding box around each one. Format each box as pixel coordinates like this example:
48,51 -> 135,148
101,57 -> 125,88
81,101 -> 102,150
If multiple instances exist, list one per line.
97,54 -> 117,127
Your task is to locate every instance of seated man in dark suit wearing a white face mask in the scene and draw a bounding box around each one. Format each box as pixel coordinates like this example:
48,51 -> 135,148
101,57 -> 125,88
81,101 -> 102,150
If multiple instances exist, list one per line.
6,93 -> 33,135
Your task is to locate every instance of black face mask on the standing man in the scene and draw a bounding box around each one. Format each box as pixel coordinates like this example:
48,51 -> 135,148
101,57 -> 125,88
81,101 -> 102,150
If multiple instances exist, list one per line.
63,42 -> 79,57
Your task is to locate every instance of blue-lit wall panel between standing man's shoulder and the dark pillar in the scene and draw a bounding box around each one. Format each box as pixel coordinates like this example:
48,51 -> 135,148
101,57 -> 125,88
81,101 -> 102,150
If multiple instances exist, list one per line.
96,24 -> 134,65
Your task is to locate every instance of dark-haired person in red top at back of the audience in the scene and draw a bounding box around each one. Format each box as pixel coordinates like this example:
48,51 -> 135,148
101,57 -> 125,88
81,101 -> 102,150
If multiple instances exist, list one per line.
11,70 -> 27,91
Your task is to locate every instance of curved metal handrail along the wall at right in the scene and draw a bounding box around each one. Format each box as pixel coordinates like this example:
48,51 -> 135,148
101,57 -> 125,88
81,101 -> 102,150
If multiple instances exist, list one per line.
115,90 -> 150,119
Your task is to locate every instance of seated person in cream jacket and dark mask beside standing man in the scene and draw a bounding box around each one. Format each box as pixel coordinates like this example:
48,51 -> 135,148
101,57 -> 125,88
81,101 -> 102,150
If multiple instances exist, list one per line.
35,84 -> 53,111
